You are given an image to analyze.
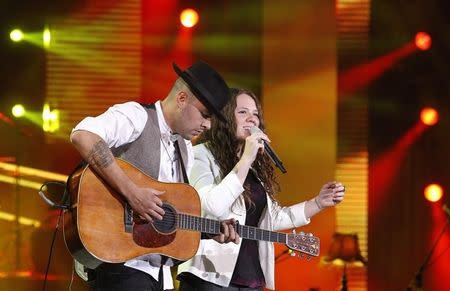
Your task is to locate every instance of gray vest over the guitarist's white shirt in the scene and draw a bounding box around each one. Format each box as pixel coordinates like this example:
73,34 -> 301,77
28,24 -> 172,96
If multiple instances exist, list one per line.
111,104 -> 187,182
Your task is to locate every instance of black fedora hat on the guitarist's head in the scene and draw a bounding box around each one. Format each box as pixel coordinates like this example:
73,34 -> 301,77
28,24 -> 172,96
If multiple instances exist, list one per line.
173,61 -> 230,121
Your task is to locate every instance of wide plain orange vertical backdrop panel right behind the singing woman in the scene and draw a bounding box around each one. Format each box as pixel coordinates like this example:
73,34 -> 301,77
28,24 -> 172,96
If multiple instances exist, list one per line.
262,0 -> 341,291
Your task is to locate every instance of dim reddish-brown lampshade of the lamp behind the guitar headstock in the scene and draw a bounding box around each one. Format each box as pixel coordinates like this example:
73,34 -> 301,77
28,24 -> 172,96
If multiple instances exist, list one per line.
324,232 -> 367,265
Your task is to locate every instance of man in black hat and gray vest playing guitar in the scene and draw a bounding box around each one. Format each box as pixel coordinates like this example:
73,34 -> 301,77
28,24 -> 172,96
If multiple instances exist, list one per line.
70,61 -> 238,291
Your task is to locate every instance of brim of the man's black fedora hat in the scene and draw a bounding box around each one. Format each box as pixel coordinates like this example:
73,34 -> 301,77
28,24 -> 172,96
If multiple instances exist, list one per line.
172,63 -> 226,122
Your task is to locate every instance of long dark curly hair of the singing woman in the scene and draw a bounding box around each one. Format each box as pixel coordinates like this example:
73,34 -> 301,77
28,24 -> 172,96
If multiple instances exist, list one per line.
197,88 -> 279,204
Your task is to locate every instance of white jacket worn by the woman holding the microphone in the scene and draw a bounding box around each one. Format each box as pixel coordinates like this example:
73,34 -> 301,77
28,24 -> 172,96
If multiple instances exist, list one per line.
178,144 -> 310,289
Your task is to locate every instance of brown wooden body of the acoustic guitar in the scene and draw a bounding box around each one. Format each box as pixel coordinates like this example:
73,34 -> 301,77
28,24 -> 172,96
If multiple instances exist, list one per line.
64,160 -> 200,269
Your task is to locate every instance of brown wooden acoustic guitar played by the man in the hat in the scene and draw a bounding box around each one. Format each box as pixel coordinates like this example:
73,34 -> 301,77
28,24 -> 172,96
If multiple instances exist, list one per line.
63,159 -> 320,269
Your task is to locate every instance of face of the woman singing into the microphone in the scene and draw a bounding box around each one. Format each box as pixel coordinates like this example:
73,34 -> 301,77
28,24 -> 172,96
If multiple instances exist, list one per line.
234,94 -> 259,140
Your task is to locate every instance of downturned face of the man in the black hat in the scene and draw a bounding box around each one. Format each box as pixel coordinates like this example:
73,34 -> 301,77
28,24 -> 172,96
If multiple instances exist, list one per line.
177,92 -> 211,140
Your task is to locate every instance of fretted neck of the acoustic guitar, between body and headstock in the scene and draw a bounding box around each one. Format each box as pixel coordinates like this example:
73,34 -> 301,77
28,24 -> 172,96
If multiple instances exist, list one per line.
177,213 -> 287,243
